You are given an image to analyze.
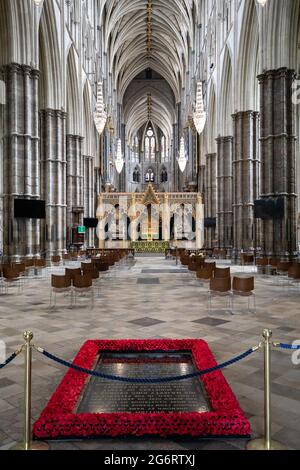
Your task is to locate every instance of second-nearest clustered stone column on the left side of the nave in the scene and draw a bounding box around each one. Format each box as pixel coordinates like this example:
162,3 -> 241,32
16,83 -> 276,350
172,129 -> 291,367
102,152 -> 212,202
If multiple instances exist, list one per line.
40,109 -> 67,256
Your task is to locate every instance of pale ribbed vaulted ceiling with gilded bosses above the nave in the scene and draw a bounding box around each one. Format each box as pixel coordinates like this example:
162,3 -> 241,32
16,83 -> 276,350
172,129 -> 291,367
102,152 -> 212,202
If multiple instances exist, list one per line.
100,0 -> 200,140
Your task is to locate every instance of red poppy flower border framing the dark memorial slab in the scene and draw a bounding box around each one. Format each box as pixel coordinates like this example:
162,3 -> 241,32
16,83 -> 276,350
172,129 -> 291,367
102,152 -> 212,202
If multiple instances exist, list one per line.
33,339 -> 251,439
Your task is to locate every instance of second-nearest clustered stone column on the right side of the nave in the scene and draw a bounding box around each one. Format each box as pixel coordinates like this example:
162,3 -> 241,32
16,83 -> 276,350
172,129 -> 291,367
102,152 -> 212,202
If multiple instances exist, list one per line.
232,111 -> 260,255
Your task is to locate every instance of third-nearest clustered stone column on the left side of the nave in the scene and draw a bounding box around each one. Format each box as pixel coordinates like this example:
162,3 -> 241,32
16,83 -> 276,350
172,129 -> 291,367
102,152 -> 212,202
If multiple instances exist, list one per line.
67,134 -> 84,243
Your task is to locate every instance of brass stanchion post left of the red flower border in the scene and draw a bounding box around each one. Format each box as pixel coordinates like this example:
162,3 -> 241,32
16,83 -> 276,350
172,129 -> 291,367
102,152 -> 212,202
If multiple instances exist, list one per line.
11,331 -> 49,450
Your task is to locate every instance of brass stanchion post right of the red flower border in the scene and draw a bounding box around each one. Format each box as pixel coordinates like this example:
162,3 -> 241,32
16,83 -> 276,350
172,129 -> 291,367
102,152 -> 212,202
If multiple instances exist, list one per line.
247,330 -> 286,450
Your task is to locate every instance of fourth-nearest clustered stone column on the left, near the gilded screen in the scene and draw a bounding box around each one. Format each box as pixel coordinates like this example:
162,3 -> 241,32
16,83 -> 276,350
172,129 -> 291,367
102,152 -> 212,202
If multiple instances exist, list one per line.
83,156 -> 95,247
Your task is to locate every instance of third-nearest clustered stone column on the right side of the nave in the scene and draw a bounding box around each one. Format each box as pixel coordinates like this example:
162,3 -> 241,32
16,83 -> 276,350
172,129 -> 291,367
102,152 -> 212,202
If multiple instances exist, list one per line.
216,136 -> 233,249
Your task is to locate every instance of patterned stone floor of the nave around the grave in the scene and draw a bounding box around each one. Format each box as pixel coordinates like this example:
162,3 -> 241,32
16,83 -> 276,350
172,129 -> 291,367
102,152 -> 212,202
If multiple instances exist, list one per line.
0,256 -> 300,450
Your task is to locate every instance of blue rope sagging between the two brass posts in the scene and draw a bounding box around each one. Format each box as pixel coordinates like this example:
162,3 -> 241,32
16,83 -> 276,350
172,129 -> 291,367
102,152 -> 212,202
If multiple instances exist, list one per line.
38,348 -> 256,384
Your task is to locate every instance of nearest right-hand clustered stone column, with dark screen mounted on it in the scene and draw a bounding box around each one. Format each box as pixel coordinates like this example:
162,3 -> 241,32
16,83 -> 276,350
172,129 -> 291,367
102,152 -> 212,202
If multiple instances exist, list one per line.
258,68 -> 297,257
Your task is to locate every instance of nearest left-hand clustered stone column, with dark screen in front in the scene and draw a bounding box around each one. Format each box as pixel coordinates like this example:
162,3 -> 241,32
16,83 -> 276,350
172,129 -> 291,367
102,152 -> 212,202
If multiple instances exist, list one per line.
1,63 -> 40,259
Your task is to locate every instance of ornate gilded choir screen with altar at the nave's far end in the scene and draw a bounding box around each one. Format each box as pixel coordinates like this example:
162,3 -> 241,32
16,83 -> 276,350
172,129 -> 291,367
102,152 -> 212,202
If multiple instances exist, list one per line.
97,184 -> 204,252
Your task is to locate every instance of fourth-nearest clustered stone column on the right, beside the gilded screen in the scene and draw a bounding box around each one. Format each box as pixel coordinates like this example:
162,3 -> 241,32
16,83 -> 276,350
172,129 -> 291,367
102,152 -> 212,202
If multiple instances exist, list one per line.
204,153 -> 217,248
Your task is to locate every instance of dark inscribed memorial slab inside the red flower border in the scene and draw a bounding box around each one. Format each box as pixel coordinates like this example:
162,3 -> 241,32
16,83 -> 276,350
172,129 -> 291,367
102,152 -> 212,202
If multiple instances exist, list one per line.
77,352 -> 210,413
